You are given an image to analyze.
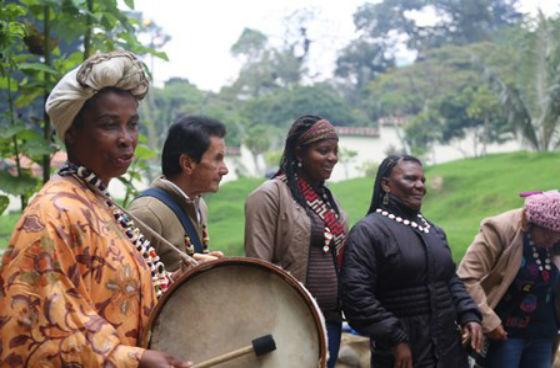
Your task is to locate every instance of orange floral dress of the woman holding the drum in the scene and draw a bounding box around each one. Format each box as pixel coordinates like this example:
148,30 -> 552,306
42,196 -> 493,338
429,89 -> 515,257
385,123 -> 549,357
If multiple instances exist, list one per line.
0,176 -> 156,367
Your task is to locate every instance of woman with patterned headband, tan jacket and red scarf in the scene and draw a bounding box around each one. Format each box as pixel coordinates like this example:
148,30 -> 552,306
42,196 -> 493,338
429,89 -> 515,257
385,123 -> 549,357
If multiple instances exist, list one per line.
245,115 -> 347,367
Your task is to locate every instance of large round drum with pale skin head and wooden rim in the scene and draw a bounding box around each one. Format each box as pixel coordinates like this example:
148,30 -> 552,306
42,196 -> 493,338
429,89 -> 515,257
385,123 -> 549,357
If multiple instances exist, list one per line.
143,258 -> 327,368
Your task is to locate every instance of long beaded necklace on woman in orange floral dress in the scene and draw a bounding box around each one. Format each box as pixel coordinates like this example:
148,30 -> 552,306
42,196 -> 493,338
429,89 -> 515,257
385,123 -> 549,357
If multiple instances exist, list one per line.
58,162 -> 171,298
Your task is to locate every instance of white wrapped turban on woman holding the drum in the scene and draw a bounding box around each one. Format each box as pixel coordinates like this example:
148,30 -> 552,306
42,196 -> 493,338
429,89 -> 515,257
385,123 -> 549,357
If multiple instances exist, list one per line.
45,51 -> 150,141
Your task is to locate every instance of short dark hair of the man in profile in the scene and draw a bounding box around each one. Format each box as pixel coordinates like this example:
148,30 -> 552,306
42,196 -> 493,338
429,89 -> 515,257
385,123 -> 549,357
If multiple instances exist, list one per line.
161,116 -> 226,179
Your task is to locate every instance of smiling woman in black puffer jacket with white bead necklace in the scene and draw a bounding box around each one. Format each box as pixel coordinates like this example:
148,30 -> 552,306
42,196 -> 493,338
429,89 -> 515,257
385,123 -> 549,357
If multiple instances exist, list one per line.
341,155 -> 482,368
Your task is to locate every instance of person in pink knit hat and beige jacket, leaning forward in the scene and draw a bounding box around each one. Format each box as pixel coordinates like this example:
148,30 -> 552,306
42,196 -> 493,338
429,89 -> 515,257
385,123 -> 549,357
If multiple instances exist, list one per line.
457,192 -> 560,368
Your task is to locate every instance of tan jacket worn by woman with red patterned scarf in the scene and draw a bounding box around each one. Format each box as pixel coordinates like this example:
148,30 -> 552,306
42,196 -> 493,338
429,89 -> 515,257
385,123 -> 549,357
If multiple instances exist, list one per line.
245,179 -> 348,283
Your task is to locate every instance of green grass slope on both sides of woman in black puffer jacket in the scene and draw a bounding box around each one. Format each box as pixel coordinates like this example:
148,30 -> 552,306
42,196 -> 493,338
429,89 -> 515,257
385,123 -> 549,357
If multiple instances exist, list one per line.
332,152 -> 560,260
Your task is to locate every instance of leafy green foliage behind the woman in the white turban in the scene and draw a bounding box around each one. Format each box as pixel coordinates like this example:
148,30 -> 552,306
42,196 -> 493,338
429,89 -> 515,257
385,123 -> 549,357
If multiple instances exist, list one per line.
0,0 -> 164,209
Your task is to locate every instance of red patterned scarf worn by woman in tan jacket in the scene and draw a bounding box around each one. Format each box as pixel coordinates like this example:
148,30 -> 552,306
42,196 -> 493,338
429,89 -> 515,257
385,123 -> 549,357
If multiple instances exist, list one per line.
279,175 -> 346,268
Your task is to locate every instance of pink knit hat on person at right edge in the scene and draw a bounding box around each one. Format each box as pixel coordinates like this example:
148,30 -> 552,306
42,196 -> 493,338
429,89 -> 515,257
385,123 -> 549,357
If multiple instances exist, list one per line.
525,192 -> 560,232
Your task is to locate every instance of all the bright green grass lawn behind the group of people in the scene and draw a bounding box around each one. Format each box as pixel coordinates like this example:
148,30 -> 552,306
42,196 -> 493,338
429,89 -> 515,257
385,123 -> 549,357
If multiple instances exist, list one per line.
0,152 -> 560,260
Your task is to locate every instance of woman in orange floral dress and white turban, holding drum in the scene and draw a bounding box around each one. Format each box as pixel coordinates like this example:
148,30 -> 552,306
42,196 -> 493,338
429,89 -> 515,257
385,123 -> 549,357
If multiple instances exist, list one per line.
0,51 -> 192,367
